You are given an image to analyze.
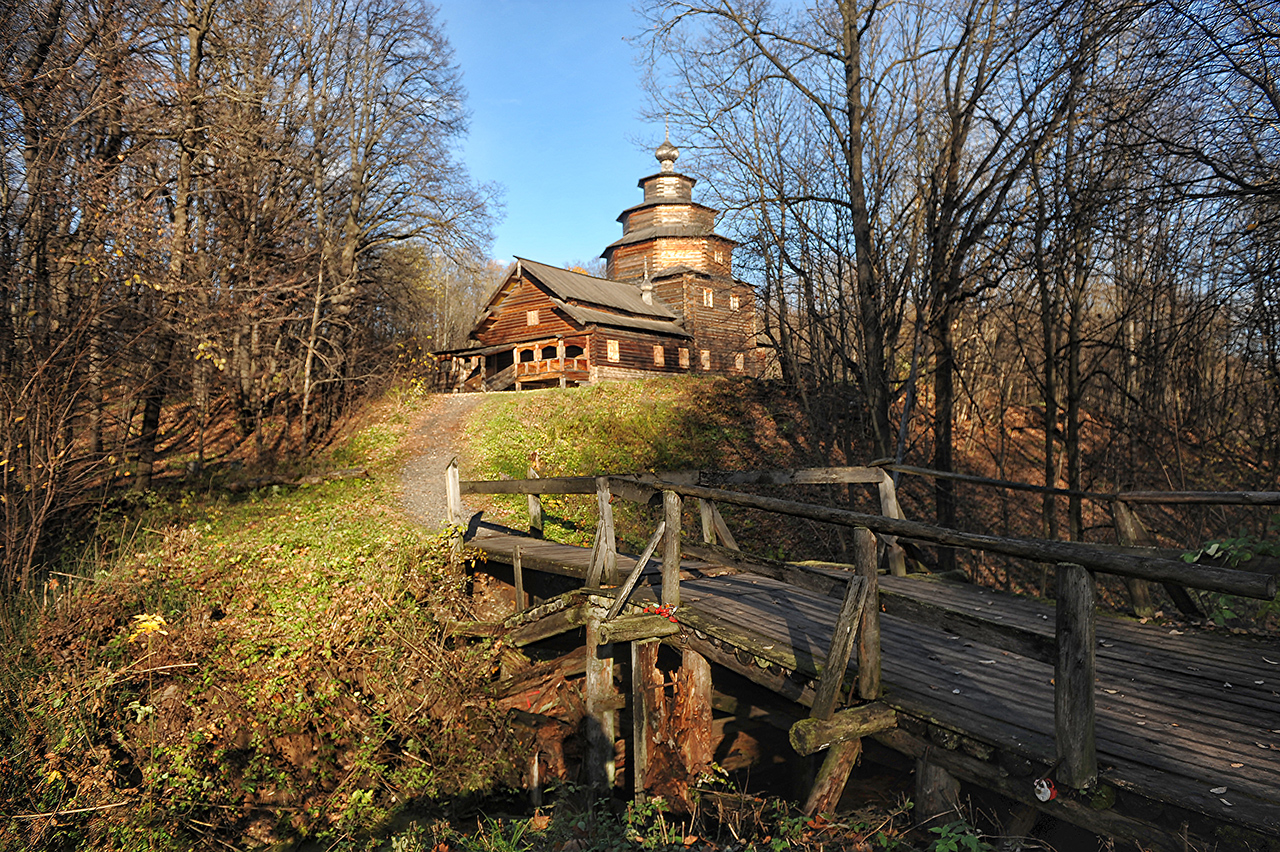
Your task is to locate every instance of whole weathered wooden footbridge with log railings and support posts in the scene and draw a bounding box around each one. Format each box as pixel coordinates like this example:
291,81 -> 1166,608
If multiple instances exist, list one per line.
448,466 -> 1280,852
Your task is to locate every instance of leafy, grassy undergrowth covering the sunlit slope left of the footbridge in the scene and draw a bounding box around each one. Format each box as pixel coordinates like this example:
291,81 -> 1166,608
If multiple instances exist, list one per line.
0,388 -> 517,851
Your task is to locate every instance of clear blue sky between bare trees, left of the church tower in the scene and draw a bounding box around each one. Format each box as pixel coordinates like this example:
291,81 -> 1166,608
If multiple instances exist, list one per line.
436,0 -> 660,266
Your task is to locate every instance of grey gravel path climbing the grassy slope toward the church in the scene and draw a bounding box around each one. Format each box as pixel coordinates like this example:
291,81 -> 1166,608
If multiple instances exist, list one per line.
401,394 -> 484,530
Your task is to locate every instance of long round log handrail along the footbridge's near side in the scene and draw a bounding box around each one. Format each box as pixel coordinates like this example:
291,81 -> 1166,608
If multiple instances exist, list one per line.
645,485 -> 1276,600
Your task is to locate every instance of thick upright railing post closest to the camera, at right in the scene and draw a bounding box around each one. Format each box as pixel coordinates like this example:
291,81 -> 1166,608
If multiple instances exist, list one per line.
1053,564 -> 1098,788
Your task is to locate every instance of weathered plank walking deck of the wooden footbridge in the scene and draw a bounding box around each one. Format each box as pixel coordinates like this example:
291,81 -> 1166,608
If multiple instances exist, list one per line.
472,531 -> 1280,837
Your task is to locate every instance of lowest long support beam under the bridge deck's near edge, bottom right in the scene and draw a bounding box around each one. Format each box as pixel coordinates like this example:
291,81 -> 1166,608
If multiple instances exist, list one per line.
874,728 -> 1187,852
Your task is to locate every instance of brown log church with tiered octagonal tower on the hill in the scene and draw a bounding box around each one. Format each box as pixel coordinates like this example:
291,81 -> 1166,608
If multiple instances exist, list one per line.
435,141 -> 759,390
